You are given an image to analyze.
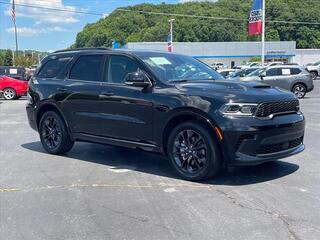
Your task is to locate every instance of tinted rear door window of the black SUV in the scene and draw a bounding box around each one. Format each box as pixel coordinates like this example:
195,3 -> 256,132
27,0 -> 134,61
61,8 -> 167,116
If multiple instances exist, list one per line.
69,55 -> 103,82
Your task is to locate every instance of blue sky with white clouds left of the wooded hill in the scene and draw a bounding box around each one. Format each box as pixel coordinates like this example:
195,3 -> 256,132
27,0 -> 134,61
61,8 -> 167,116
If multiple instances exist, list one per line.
0,0 -> 215,51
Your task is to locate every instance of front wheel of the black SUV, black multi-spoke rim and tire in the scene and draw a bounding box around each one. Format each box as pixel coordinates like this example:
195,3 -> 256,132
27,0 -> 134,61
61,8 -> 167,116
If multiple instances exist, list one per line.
167,122 -> 221,181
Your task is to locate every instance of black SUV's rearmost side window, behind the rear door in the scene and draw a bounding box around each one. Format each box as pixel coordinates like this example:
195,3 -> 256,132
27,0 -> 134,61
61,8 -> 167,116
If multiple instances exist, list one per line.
38,57 -> 70,78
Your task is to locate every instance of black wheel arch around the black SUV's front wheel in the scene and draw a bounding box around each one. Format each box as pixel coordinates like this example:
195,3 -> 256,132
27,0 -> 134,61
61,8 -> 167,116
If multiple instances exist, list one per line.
162,108 -> 223,156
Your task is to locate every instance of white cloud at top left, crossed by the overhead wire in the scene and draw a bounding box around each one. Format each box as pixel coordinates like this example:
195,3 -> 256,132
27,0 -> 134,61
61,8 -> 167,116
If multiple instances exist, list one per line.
5,0 -> 79,25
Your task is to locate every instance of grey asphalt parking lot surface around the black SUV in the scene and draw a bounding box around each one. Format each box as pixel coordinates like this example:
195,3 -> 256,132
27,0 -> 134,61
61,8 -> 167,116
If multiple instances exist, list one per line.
0,80 -> 320,240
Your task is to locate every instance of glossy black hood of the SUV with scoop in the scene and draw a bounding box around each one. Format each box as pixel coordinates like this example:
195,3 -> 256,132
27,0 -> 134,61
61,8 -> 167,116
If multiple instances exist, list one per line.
175,80 -> 295,103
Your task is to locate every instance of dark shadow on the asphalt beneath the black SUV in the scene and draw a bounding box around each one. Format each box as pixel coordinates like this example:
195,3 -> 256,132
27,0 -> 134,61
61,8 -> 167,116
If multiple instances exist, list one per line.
21,141 -> 299,186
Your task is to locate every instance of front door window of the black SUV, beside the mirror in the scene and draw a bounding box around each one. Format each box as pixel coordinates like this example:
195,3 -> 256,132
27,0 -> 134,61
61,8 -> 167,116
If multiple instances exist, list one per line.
108,56 -> 139,83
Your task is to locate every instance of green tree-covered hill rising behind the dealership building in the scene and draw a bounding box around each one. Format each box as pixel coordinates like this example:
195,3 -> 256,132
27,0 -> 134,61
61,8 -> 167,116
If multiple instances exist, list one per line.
72,0 -> 320,48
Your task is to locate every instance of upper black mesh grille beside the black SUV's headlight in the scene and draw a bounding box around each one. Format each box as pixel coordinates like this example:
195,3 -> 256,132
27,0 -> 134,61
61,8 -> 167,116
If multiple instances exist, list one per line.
256,100 -> 299,117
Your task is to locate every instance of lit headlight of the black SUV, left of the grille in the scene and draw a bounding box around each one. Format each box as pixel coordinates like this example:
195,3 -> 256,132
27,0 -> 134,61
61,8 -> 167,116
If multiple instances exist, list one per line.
220,103 -> 258,117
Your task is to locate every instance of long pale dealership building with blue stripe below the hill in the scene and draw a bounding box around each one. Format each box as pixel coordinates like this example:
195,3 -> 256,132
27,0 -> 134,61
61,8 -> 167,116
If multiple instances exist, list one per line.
124,41 -> 320,67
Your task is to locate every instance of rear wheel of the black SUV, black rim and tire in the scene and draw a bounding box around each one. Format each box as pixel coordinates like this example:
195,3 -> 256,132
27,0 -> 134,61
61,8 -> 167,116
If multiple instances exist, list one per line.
39,111 -> 74,154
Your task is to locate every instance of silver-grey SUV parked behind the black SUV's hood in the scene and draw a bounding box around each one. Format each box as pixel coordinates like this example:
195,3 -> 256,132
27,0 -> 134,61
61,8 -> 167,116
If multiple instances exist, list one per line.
239,65 -> 314,98
